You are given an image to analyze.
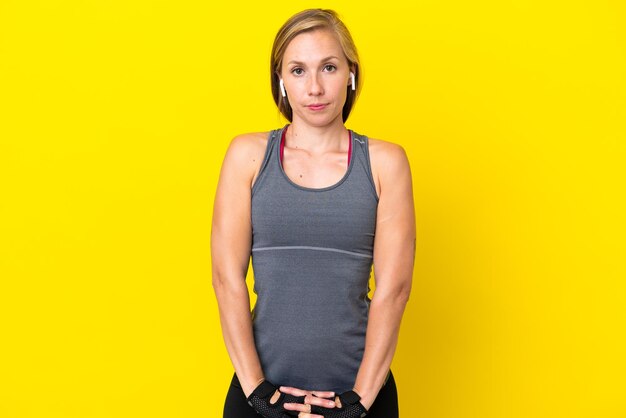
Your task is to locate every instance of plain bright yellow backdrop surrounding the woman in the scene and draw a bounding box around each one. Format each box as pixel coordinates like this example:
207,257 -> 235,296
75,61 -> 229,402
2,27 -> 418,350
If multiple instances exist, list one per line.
0,0 -> 626,418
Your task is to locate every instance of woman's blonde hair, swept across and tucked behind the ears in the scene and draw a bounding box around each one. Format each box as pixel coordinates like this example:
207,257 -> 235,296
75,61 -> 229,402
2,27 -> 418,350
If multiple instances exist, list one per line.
270,9 -> 363,122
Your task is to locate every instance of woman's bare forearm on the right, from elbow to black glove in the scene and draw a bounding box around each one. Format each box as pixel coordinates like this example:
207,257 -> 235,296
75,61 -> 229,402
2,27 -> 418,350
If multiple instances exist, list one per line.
354,290 -> 408,409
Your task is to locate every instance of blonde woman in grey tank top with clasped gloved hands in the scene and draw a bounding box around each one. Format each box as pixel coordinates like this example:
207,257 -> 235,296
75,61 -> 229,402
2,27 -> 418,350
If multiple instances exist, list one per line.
211,9 -> 415,418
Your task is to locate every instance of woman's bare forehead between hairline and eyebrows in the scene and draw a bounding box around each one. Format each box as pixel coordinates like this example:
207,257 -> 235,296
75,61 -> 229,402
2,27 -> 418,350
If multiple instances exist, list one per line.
283,29 -> 346,64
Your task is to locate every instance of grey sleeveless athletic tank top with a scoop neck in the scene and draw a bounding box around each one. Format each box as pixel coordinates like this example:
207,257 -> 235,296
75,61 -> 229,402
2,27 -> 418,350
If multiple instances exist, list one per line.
251,125 -> 378,393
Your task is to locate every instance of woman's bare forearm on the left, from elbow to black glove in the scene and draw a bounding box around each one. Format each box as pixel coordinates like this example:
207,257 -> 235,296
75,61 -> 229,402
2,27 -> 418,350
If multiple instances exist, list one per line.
213,274 -> 264,396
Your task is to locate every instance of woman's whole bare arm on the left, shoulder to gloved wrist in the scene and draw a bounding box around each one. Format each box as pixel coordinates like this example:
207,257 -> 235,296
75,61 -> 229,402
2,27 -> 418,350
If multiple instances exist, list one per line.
211,134 -> 264,397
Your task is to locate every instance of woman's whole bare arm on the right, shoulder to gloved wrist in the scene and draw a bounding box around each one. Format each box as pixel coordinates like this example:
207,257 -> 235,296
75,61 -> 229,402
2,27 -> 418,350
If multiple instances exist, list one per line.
354,141 -> 415,410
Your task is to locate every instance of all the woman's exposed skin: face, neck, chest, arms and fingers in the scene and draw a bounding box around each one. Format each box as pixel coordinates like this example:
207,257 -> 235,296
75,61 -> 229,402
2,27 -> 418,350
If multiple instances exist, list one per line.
211,30 -> 415,418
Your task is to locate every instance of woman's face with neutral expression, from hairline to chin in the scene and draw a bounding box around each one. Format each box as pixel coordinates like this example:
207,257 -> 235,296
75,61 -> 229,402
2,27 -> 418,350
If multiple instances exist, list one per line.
280,29 -> 350,126
